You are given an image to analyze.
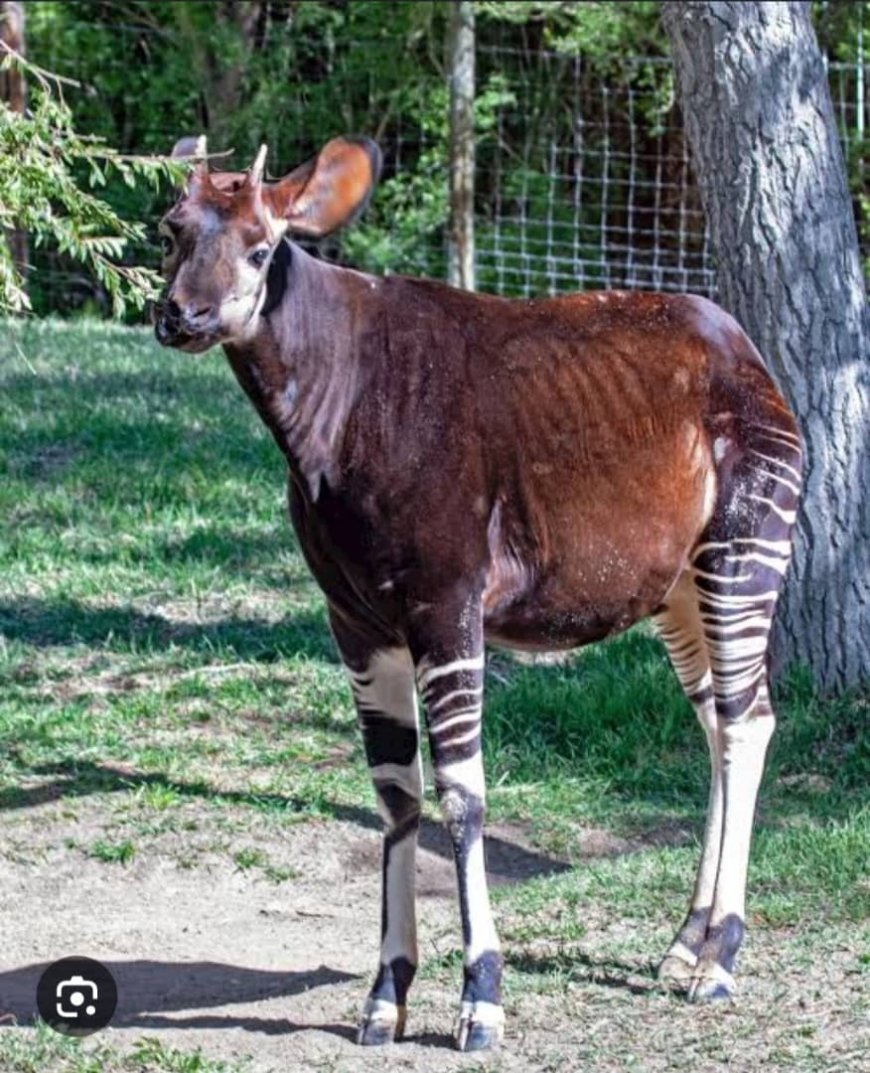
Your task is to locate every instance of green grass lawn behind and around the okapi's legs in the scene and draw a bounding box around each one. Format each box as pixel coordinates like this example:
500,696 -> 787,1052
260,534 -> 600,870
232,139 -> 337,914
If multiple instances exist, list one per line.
0,322 -> 870,1073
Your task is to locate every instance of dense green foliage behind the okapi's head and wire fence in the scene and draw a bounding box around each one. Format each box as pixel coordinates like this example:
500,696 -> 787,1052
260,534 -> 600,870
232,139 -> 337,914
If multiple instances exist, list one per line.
15,0 -> 870,312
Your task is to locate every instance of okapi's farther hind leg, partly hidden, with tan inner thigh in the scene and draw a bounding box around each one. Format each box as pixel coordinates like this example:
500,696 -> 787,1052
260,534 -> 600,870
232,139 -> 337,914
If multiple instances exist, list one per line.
654,571 -> 722,986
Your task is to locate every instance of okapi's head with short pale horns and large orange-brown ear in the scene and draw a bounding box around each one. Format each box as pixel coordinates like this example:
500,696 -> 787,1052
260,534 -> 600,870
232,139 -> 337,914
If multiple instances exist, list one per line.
154,137 -> 381,353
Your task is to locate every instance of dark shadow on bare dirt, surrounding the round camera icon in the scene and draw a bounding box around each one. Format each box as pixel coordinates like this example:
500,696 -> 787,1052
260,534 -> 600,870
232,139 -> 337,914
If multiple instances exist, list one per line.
0,960 -> 360,1039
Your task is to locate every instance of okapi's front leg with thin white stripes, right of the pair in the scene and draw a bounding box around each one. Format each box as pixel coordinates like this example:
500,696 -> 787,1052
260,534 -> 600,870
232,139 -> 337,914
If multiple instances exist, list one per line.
415,609 -> 504,1050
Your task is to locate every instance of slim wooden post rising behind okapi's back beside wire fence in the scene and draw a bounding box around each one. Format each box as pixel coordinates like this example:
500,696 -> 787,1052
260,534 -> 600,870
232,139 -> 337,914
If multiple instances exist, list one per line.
447,0 -> 474,291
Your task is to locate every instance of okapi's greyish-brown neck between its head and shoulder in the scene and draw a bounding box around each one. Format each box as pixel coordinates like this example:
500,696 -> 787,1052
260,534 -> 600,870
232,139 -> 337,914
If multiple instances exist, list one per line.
224,241 -> 371,501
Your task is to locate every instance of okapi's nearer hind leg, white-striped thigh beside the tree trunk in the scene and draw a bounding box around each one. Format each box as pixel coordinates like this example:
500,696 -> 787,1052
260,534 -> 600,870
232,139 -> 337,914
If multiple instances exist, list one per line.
689,416 -> 800,1001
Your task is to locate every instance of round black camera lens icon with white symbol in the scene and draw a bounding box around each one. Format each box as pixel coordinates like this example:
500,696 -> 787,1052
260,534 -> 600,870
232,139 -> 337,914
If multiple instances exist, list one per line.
36,957 -> 118,1035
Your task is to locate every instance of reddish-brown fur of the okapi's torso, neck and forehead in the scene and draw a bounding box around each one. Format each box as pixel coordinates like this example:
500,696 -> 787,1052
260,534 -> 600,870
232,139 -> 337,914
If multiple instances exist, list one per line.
154,145 -> 795,648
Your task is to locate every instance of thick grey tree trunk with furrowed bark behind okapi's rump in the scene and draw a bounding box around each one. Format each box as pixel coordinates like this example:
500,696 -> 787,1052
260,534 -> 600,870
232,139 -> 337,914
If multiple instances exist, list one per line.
662,0 -> 870,690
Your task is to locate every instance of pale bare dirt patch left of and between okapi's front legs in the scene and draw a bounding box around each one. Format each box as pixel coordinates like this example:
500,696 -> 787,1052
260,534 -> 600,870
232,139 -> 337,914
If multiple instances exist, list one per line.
0,806 -> 566,1071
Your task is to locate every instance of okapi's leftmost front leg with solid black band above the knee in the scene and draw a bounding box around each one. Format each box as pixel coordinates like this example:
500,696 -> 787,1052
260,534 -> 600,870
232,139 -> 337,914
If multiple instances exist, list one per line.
333,615 -> 423,1045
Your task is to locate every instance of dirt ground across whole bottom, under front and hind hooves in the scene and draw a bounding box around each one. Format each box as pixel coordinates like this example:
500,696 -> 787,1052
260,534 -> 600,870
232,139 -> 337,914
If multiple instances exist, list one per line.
0,802 -> 868,1073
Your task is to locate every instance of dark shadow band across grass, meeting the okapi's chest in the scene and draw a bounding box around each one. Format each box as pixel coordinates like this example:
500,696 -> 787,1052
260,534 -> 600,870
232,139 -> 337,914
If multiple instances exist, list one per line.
0,598 -> 338,663
